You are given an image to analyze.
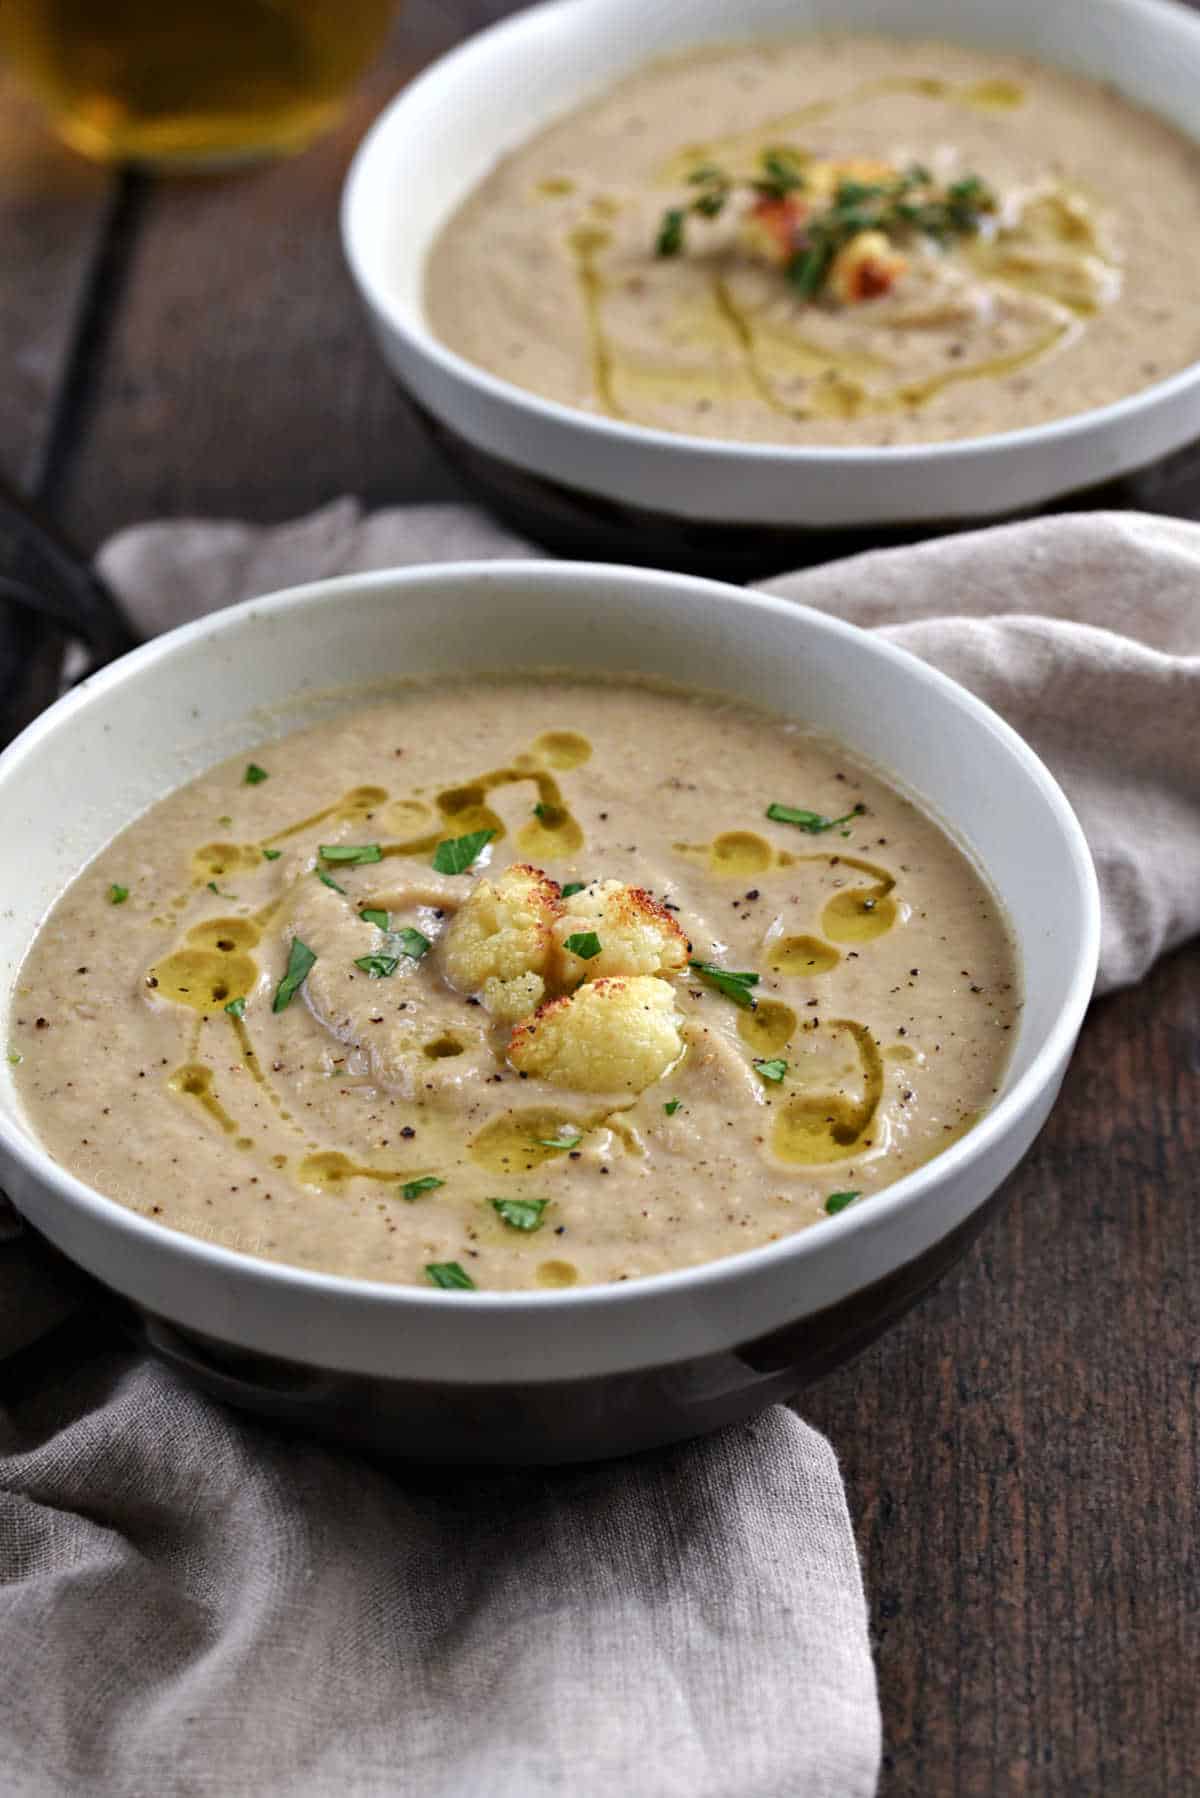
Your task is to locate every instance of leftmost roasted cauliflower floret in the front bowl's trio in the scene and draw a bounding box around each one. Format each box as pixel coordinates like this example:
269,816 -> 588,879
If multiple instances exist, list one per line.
441,863 -> 561,1021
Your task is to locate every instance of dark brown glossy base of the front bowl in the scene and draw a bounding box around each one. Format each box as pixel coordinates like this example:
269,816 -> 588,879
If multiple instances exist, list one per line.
115,1187 -> 1007,1467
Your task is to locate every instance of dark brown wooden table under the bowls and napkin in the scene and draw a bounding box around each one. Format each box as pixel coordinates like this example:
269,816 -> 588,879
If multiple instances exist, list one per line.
0,10 -> 1200,1798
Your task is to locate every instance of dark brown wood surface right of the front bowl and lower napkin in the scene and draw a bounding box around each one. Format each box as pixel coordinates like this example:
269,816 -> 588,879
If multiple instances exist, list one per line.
799,944 -> 1200,1798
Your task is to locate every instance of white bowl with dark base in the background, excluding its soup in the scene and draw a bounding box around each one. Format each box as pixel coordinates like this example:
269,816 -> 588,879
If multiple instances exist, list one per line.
342,0 -> 1200,539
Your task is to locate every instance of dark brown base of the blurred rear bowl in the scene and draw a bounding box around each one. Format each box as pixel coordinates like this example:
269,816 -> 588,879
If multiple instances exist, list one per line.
414,405 -> 1200,581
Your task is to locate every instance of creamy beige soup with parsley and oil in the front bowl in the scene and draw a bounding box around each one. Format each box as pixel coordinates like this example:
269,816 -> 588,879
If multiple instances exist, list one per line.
9,674 -> 1020,1289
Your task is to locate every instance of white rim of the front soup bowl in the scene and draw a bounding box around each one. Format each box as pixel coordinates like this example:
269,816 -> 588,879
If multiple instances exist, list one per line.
0,561 -> 1099,1337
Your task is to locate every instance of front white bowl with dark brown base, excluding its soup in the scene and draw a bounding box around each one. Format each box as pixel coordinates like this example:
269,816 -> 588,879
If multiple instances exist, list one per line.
0,563 -> 1099,1460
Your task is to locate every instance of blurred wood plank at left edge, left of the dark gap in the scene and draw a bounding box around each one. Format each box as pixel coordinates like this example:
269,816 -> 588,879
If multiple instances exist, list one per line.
0,68 -> 113,487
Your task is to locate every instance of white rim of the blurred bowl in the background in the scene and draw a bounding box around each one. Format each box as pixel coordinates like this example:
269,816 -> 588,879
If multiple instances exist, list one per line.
342,0 -> 1200,471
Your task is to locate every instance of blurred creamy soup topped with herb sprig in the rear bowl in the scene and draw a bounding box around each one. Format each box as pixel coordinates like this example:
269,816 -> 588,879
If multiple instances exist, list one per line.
426,36 -> 1200,446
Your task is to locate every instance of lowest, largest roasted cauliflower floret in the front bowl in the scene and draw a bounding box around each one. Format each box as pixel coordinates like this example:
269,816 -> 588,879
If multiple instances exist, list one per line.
509,975 -> 684,1093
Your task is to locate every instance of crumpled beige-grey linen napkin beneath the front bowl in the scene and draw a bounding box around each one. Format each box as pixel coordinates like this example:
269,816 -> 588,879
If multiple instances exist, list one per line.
0,502 -> 1200,1798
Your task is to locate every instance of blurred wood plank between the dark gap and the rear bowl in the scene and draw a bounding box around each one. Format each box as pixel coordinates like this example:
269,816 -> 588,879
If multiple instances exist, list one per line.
52,0 -> 513,545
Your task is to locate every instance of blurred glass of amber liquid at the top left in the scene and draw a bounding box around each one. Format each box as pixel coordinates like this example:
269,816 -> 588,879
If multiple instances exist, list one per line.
0,0 -> 396,169
